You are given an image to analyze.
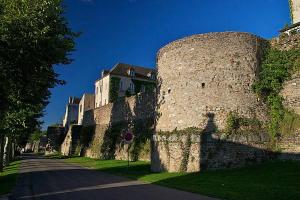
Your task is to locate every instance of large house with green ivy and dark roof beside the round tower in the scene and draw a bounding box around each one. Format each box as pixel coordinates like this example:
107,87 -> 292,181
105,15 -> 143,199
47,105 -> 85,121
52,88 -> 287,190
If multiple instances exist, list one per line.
95,63 -> 156,108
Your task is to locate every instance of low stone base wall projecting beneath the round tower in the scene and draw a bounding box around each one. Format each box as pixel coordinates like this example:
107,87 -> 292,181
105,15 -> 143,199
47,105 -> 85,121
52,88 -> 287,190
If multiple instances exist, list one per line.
151,130 -> 300,172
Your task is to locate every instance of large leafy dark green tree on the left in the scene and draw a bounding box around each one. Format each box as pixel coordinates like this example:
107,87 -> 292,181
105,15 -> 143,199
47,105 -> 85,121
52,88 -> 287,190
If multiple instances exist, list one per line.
0,0 -> 78,170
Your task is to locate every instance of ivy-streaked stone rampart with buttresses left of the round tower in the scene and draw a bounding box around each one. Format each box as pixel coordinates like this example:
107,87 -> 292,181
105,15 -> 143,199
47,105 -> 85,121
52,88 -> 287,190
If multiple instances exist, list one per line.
61,93 -> 154,160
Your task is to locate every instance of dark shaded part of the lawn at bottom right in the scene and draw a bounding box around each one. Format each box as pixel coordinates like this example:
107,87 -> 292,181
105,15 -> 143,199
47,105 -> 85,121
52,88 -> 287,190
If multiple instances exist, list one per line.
153,161 -> 300,200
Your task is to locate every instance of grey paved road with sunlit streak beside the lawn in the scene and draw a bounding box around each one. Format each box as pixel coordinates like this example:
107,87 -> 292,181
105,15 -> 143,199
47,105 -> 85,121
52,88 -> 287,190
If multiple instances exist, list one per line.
10,156 -> 215,200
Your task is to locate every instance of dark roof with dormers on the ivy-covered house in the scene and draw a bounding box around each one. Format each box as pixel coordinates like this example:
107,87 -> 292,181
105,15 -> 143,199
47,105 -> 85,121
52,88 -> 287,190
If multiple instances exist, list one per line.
98,63 -> 155,81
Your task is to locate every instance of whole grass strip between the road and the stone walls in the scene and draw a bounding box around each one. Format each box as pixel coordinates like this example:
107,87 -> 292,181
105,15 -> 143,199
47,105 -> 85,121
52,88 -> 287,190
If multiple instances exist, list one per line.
65,157 -> 300,200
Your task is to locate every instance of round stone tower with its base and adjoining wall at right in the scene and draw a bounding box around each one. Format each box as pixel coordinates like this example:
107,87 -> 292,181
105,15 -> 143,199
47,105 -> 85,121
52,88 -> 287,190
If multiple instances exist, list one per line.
151,32 -> 300,172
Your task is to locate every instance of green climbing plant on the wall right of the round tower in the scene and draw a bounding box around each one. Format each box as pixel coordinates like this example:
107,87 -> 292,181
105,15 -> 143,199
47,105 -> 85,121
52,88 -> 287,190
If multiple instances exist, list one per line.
253,43 -> 300,138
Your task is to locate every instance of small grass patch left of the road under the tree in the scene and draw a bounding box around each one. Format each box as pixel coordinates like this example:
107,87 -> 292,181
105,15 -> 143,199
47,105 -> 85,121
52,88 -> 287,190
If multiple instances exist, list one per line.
0,161 -> 20,196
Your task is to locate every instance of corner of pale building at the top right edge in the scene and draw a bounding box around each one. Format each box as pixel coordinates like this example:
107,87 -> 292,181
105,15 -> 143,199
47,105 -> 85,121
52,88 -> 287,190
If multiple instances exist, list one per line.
280,0 -> 300,35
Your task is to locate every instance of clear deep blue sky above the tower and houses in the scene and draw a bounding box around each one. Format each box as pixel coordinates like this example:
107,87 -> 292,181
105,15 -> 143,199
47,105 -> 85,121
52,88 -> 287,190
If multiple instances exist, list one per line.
43,0 -> 290,128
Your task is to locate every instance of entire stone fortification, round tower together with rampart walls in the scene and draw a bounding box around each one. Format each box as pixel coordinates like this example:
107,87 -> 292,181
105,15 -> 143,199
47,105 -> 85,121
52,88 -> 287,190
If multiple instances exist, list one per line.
44,1 -> 300,172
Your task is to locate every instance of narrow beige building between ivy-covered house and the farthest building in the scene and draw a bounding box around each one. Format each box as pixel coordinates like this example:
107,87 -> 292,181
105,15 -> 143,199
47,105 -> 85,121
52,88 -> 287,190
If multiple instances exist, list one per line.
78,93 -> 95,125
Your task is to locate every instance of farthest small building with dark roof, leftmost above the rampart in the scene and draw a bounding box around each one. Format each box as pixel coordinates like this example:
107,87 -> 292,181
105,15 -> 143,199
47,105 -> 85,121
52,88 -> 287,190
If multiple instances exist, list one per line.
63,97 -> 80,130
